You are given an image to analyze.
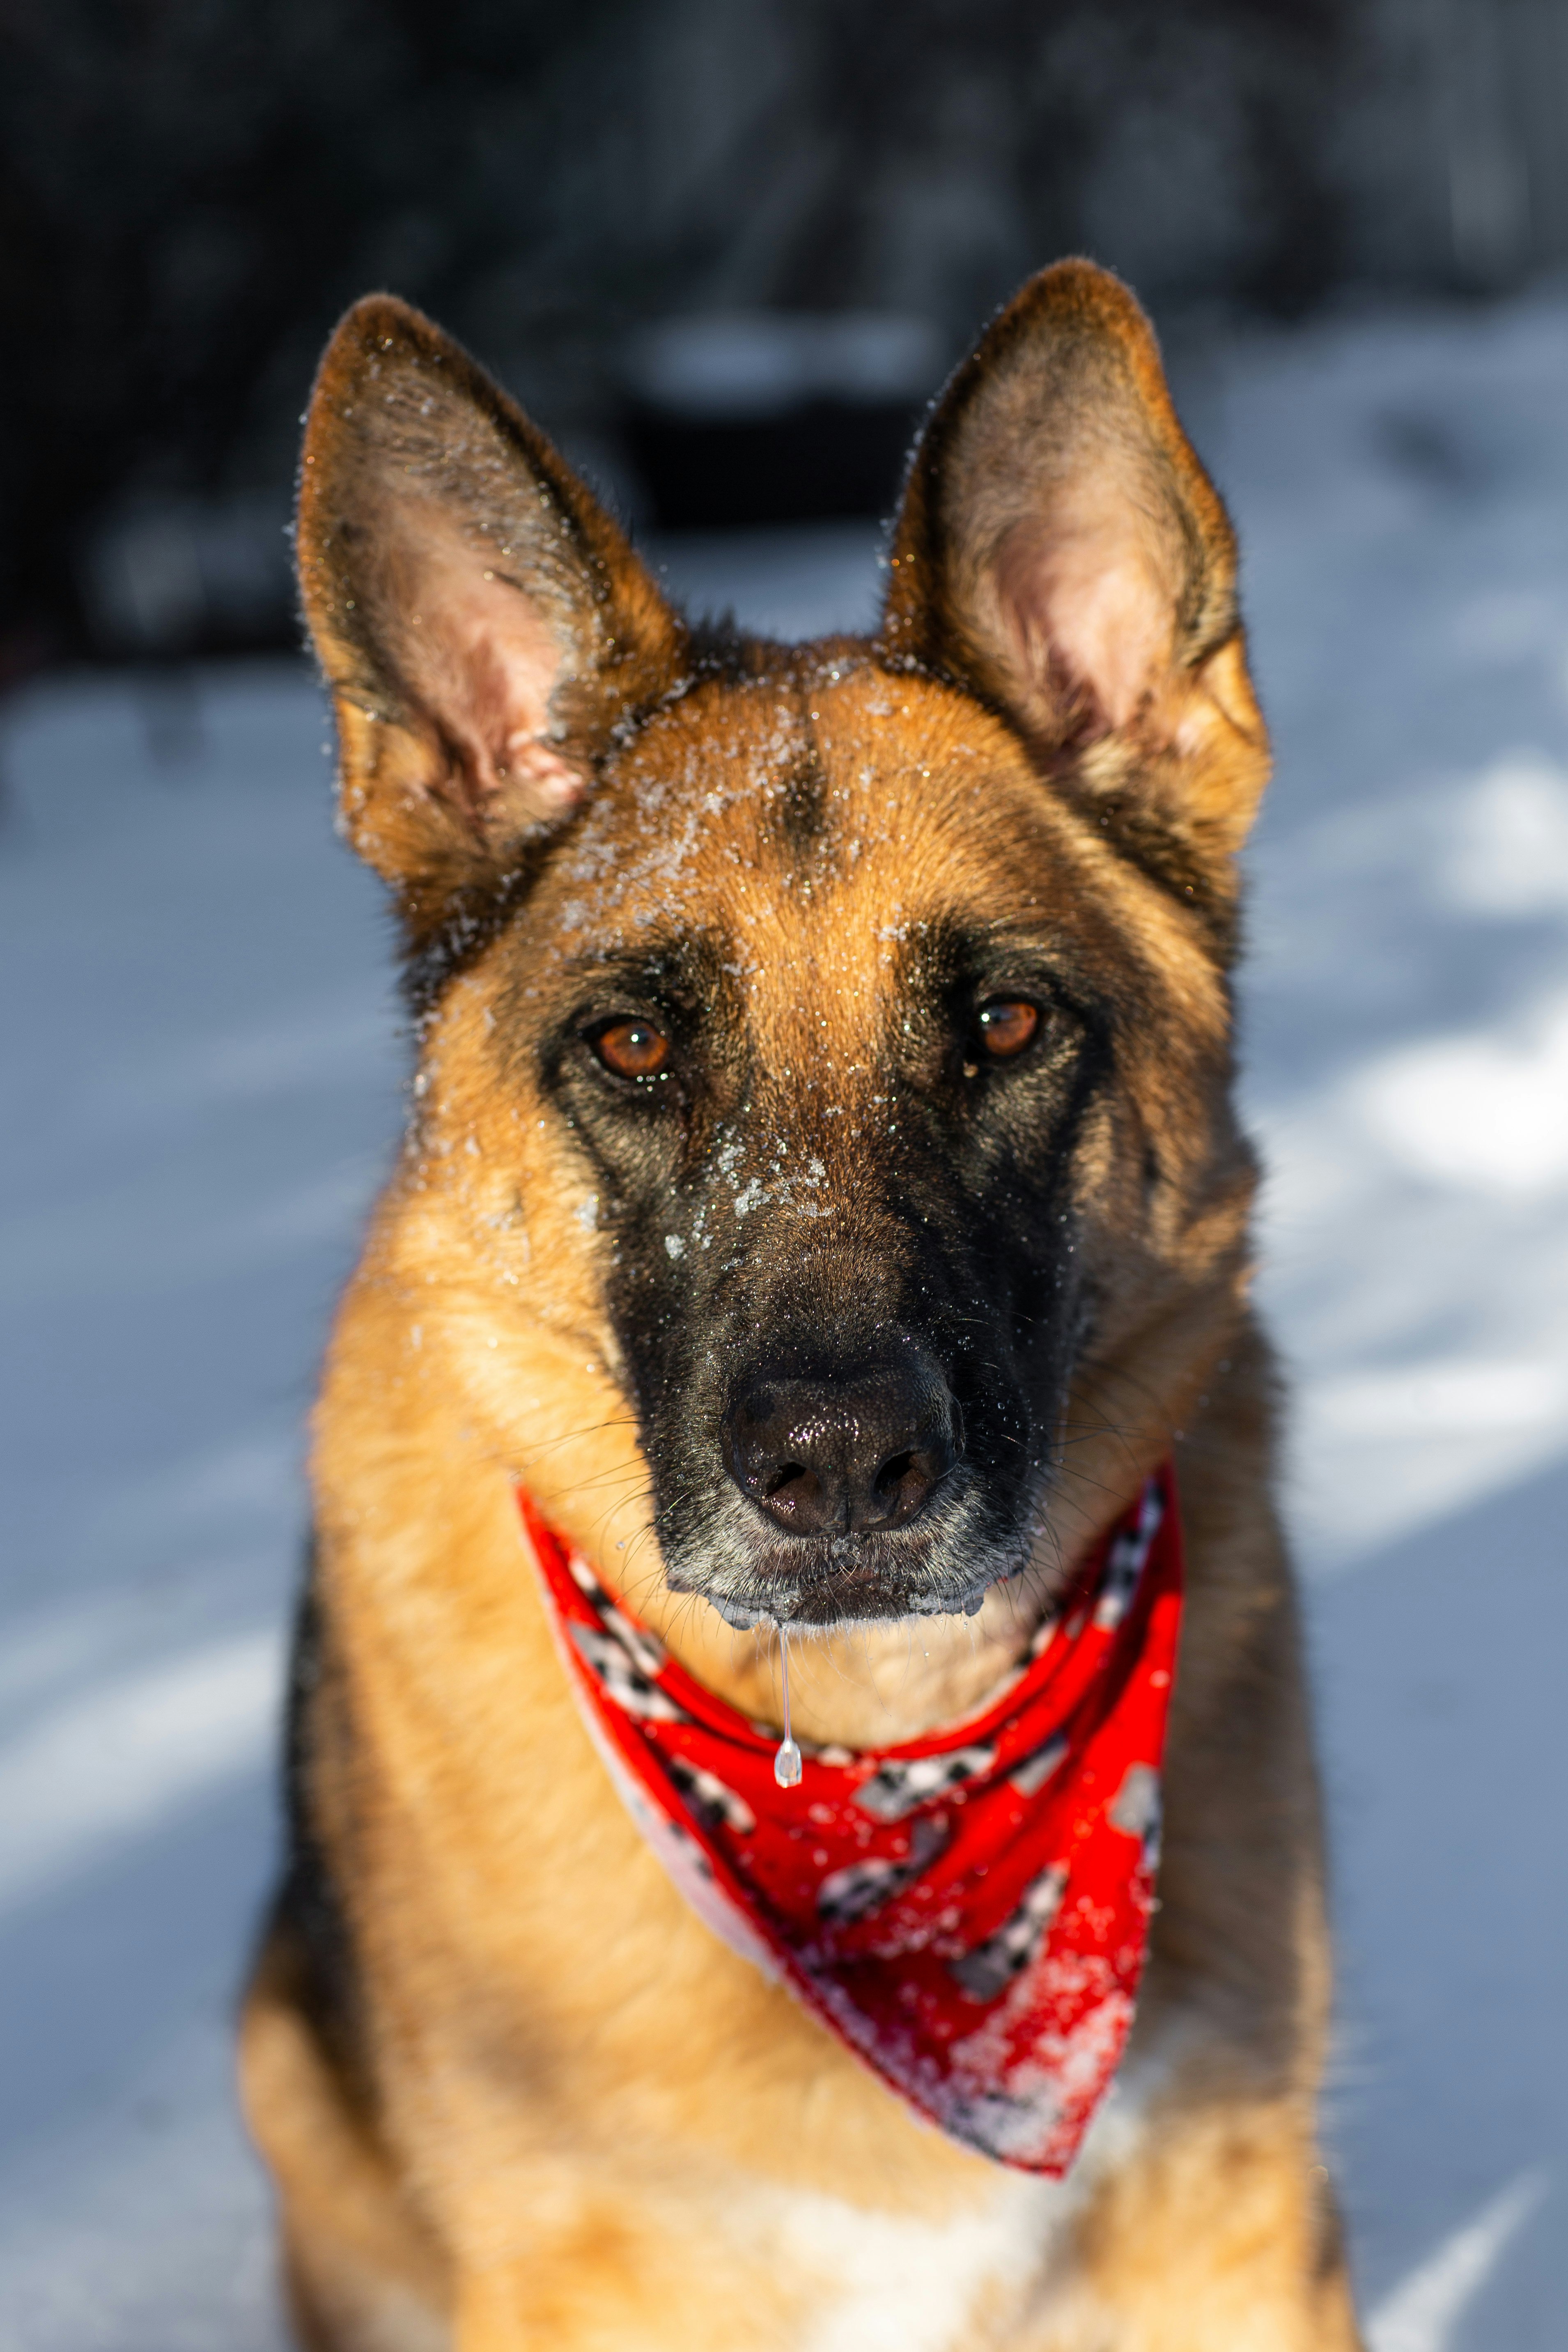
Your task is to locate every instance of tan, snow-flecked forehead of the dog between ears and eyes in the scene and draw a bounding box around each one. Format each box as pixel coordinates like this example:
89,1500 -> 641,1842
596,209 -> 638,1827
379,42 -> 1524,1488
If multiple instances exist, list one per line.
536,659 -> 1079,1011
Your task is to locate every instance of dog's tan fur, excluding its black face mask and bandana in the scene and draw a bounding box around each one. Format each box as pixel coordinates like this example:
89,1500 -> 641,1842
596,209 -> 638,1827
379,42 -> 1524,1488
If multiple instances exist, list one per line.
244,264 -> 1357,2352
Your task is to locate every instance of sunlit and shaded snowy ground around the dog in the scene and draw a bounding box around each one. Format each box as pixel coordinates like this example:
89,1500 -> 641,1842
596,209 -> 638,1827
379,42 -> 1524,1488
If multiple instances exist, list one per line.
0,301 -> 1568,2352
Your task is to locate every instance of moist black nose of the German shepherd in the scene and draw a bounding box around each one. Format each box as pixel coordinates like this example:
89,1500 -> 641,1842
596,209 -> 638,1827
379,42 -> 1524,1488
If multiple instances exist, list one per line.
724,1357 -> 964,1536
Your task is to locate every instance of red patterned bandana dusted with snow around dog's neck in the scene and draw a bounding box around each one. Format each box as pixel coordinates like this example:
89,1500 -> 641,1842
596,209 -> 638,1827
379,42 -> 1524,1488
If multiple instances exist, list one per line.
517,1465 -> 1182,2175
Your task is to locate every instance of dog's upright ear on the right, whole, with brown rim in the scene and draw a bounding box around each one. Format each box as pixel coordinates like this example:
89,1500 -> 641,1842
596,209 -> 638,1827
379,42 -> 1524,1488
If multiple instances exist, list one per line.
882,261 -> 1267,851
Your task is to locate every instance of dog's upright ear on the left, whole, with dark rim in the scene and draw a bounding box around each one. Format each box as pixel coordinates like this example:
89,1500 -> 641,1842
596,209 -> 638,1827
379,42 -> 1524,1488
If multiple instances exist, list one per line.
298,294 -> 684,920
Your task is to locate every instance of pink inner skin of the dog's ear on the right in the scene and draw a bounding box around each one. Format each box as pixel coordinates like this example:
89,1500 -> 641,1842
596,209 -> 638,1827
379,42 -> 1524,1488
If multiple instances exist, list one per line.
992,491 -> 1175,741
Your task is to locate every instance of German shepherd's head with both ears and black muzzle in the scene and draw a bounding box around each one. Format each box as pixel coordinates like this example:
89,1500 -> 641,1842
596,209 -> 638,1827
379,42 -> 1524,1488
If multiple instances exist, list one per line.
301,264 -> 1267,1625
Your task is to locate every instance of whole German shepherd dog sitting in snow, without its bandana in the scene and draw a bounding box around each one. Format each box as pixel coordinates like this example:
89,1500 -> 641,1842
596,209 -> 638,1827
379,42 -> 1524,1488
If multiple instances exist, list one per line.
242,261 -> 1359,2352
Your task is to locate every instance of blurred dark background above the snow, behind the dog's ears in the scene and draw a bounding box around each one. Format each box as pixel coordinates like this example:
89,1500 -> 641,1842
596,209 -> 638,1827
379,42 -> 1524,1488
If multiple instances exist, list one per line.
0,0 -> 1568,677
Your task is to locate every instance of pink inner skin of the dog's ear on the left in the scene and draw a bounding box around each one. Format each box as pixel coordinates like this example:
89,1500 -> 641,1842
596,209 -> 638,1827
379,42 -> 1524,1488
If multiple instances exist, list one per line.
393,508 -> 583,821
